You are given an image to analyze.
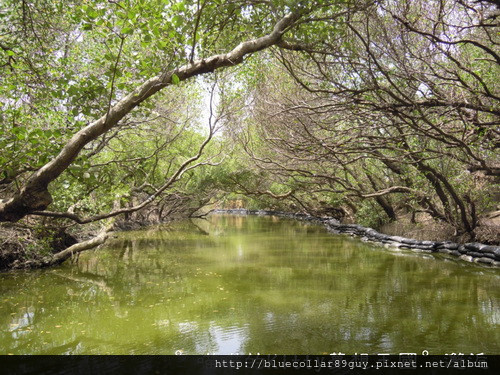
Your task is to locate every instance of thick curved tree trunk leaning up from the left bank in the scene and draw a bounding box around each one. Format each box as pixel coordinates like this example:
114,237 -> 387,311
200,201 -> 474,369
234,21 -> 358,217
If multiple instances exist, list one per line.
0,12 -> 301,222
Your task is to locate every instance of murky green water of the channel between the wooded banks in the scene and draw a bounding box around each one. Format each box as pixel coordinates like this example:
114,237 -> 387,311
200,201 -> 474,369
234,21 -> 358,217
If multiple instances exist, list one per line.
0,216 -> 500,354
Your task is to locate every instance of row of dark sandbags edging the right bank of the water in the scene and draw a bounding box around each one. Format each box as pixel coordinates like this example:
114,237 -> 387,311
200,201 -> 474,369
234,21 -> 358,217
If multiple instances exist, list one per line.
212,209 -> 500,267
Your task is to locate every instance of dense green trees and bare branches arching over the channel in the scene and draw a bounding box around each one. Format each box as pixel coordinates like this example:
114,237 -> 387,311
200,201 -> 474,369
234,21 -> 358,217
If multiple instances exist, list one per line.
0,0 -> 500,270
